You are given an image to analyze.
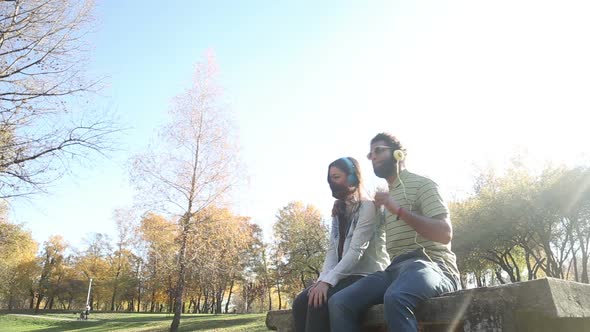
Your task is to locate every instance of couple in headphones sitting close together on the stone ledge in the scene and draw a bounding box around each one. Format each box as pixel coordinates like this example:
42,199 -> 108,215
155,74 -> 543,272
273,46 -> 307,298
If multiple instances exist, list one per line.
293,133 -> 459,332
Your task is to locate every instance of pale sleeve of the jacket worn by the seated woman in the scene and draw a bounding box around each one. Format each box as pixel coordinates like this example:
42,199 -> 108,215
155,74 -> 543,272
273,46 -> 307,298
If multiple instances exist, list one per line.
318,201 -> 377,286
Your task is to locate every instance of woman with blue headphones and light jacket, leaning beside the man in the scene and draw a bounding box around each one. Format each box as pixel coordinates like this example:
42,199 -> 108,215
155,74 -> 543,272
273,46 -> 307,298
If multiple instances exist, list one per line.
293,157 -> 389,332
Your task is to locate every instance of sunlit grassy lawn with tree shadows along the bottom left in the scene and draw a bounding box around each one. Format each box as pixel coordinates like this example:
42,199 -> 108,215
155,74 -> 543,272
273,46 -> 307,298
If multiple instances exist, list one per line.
0,311 -> 267,332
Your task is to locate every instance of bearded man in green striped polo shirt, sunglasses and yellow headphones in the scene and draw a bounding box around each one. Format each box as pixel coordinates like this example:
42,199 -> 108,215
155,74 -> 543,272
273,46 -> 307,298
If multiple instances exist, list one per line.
329,133 -> 459,332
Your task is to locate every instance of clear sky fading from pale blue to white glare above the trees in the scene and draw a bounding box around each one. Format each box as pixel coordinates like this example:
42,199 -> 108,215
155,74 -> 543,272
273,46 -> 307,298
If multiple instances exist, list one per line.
12,0 -> 590,246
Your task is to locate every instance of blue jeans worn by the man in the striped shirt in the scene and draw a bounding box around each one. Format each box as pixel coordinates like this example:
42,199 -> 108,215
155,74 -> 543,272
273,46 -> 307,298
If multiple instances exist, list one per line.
328,251 -> 458,332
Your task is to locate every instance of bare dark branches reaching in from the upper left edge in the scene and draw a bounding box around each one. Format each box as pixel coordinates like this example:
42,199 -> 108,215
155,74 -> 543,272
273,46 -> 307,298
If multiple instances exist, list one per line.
0,0 -> 115,198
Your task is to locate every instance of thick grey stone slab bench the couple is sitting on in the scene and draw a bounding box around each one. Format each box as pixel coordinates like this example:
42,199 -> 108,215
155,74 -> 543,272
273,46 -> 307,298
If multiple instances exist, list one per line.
266,278 -> 590,332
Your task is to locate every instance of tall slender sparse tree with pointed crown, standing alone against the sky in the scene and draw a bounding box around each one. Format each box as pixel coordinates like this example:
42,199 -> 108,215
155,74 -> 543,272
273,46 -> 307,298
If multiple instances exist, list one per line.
131,54 -> 237,331
